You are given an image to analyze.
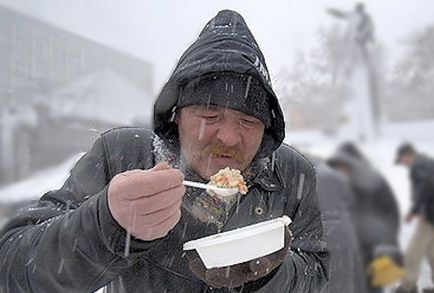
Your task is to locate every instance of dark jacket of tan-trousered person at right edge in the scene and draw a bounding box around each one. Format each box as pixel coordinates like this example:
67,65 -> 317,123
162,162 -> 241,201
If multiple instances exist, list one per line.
410,154 -> 434,225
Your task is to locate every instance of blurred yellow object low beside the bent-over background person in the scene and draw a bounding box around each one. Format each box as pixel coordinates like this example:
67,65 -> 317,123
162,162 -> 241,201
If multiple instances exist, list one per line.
368,256 -> 404,287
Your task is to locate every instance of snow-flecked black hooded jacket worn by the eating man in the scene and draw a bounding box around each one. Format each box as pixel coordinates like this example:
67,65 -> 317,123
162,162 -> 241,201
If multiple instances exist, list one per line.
0,11 -> 328,293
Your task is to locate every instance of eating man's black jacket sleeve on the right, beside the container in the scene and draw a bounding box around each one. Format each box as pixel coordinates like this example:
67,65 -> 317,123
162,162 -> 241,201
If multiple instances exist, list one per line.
259,151 -> 329,292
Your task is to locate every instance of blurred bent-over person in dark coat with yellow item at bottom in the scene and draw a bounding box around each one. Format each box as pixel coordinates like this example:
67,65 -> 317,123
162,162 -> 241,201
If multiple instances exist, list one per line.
328,142 -> 403,292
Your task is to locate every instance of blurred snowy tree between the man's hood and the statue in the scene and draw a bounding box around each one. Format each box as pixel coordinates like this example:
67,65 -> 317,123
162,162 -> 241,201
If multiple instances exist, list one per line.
276,27 -> 347,132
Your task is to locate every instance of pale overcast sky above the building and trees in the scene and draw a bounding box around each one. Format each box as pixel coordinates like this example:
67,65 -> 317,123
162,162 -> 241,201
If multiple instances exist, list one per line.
0,0 -> 434,91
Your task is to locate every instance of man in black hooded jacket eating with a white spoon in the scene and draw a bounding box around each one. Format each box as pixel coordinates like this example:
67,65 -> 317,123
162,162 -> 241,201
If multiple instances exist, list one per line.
0,10 -> 328,293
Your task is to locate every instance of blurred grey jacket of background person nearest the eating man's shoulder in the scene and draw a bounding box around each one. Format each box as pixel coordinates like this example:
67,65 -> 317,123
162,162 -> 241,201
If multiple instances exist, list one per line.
314,162 -> 367,293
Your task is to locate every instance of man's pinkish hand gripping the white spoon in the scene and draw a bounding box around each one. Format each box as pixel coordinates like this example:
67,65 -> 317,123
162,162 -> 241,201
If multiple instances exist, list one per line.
107,163 -> 185,241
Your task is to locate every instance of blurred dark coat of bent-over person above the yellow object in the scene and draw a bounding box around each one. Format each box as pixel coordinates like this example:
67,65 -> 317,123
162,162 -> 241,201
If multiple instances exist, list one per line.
329,150 -> 400,266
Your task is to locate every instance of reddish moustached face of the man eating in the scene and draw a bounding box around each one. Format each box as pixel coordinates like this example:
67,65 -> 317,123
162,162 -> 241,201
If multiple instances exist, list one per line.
176,105 -> 265,180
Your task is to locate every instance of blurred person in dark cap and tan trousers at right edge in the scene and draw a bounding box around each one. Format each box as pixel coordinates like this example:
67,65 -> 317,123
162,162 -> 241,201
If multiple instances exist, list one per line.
395,143 -> 434,293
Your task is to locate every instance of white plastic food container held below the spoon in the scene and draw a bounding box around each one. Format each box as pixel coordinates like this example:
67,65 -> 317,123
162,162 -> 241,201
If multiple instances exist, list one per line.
184,216 -> 291,269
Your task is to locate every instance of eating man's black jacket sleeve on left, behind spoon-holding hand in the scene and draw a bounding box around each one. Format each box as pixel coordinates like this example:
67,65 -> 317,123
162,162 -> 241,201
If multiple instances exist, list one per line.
0,132 -> 156,292
